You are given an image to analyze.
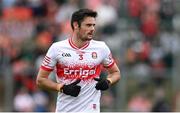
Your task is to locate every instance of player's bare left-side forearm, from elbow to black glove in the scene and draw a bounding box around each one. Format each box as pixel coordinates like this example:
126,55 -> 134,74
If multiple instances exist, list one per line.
36,78 -> 63,91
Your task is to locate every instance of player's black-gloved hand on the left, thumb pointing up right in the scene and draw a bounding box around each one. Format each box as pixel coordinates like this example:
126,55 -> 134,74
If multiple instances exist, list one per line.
61,79 -> 81,97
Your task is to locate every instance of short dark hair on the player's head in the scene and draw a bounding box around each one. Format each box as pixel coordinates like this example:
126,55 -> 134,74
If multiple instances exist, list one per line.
71,9 -> 97,30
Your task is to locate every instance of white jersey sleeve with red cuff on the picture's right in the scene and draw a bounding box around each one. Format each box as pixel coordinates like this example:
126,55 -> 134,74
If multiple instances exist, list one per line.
102,43 -> 114,68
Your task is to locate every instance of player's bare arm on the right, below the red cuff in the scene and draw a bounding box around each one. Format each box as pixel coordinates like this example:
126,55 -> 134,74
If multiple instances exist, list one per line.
107,64 -> 121,85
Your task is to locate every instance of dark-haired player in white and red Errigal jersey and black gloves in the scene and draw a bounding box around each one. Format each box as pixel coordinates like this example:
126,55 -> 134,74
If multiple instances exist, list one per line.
36,9 -> 120,112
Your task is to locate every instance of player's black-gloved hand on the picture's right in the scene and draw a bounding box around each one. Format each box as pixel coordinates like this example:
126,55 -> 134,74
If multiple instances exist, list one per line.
94,78 -> 110,91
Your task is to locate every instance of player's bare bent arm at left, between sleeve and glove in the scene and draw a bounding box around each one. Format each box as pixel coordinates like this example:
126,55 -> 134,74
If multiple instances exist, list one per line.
36,68 -> 63,91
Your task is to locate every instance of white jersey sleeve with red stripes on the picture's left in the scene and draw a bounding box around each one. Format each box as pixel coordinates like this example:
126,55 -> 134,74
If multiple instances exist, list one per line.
41,44 -> 57,71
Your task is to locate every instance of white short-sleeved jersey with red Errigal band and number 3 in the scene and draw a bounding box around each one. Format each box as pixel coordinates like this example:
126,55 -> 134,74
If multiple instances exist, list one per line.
41,38 -> 114,112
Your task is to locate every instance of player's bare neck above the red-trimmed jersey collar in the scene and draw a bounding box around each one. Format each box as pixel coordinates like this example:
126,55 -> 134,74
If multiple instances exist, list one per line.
72,35 -> 89,48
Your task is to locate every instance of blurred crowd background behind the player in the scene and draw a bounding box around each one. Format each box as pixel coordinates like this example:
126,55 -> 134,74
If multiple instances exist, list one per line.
0,0 -> 180,112
